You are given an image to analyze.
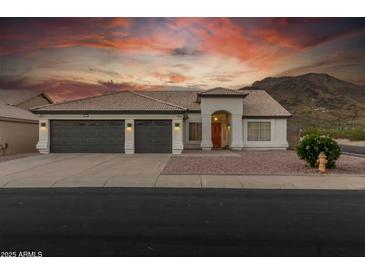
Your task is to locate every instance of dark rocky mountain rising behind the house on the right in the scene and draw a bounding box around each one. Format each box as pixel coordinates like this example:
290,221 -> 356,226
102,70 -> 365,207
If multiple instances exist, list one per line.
241,73 -> 365,129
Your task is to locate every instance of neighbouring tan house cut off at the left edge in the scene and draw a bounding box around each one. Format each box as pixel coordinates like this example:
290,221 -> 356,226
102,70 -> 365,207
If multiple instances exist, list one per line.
0,89 -> 52,156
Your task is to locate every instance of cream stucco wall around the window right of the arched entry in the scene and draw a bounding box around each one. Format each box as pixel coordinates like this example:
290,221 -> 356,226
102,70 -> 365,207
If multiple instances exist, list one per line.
242,119 -> 289,150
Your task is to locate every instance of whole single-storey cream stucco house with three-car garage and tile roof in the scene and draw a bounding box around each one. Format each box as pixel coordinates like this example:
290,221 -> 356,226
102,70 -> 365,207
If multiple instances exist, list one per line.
32,88 -> 291,154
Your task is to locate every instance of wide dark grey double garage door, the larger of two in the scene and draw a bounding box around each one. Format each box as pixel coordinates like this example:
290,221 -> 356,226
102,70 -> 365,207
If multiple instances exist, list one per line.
51,120 -> 124,153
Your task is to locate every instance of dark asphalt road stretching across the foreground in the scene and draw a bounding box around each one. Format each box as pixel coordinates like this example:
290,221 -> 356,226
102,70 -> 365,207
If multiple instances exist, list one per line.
0,188 -> 365,256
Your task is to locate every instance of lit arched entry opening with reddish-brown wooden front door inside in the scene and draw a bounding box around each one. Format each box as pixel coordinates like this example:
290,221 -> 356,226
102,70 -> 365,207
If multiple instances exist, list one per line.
211,110 -> 232,149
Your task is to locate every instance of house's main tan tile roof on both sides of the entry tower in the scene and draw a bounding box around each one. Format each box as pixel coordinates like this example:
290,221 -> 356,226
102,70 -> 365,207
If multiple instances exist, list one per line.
33,89 -> 291,117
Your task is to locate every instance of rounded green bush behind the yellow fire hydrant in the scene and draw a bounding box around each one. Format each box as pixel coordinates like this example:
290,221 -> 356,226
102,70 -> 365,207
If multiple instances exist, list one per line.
297,134 -> 341,168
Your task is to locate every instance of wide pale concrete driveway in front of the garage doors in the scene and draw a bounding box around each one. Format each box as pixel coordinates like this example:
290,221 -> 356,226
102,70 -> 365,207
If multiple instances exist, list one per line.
0,154 -> 170,187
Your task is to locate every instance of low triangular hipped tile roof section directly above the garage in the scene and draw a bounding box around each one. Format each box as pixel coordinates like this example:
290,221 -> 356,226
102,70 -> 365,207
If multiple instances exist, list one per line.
32,91 -> 186,112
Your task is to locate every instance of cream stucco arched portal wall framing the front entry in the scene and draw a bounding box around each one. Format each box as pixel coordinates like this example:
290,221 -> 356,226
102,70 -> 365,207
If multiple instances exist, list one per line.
201,98 -> 244,150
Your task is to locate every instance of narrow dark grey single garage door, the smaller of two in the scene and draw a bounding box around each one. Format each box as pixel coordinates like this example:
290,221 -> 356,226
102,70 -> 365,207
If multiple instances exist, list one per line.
134,120 -> 172,153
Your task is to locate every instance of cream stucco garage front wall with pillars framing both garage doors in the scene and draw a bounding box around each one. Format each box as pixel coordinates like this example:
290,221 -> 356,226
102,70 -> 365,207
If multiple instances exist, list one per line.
37,114 -> 184,154
